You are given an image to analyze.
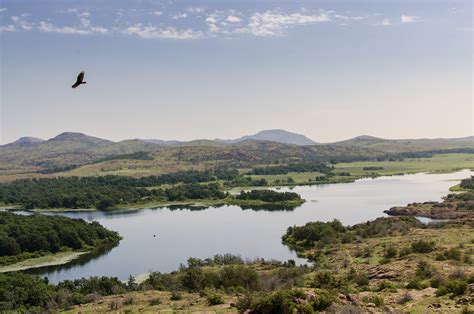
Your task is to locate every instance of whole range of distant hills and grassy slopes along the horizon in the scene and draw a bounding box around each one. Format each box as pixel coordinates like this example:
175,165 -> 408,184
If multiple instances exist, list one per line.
0,130 -> 474,180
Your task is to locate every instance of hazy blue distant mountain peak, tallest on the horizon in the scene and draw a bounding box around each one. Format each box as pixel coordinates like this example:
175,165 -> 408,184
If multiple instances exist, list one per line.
215,129 -> 316,145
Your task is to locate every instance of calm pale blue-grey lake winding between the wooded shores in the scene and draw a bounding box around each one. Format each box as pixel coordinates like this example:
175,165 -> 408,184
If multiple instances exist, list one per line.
35,171 -> 472,282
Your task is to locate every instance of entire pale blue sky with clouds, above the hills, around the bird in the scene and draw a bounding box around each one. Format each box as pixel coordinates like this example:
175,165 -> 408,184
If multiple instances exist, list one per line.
0,0 -> 474,144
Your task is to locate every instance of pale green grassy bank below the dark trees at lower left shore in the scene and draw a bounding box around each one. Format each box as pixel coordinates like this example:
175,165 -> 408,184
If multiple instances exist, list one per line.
0,251 -> 88,273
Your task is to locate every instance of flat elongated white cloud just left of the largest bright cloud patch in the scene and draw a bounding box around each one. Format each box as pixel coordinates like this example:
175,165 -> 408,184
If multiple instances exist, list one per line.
123,23 -> 203,39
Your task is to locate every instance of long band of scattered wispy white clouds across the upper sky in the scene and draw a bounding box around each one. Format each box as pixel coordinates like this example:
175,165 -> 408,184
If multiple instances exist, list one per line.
0,7 -> 392,39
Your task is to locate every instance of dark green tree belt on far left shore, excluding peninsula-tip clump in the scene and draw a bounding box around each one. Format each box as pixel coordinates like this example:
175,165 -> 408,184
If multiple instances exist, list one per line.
0,177 -> 230,209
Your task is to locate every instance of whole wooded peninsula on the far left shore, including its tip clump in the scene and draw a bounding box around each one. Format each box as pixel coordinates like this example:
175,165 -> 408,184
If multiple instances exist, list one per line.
0,171 -> 304,210
